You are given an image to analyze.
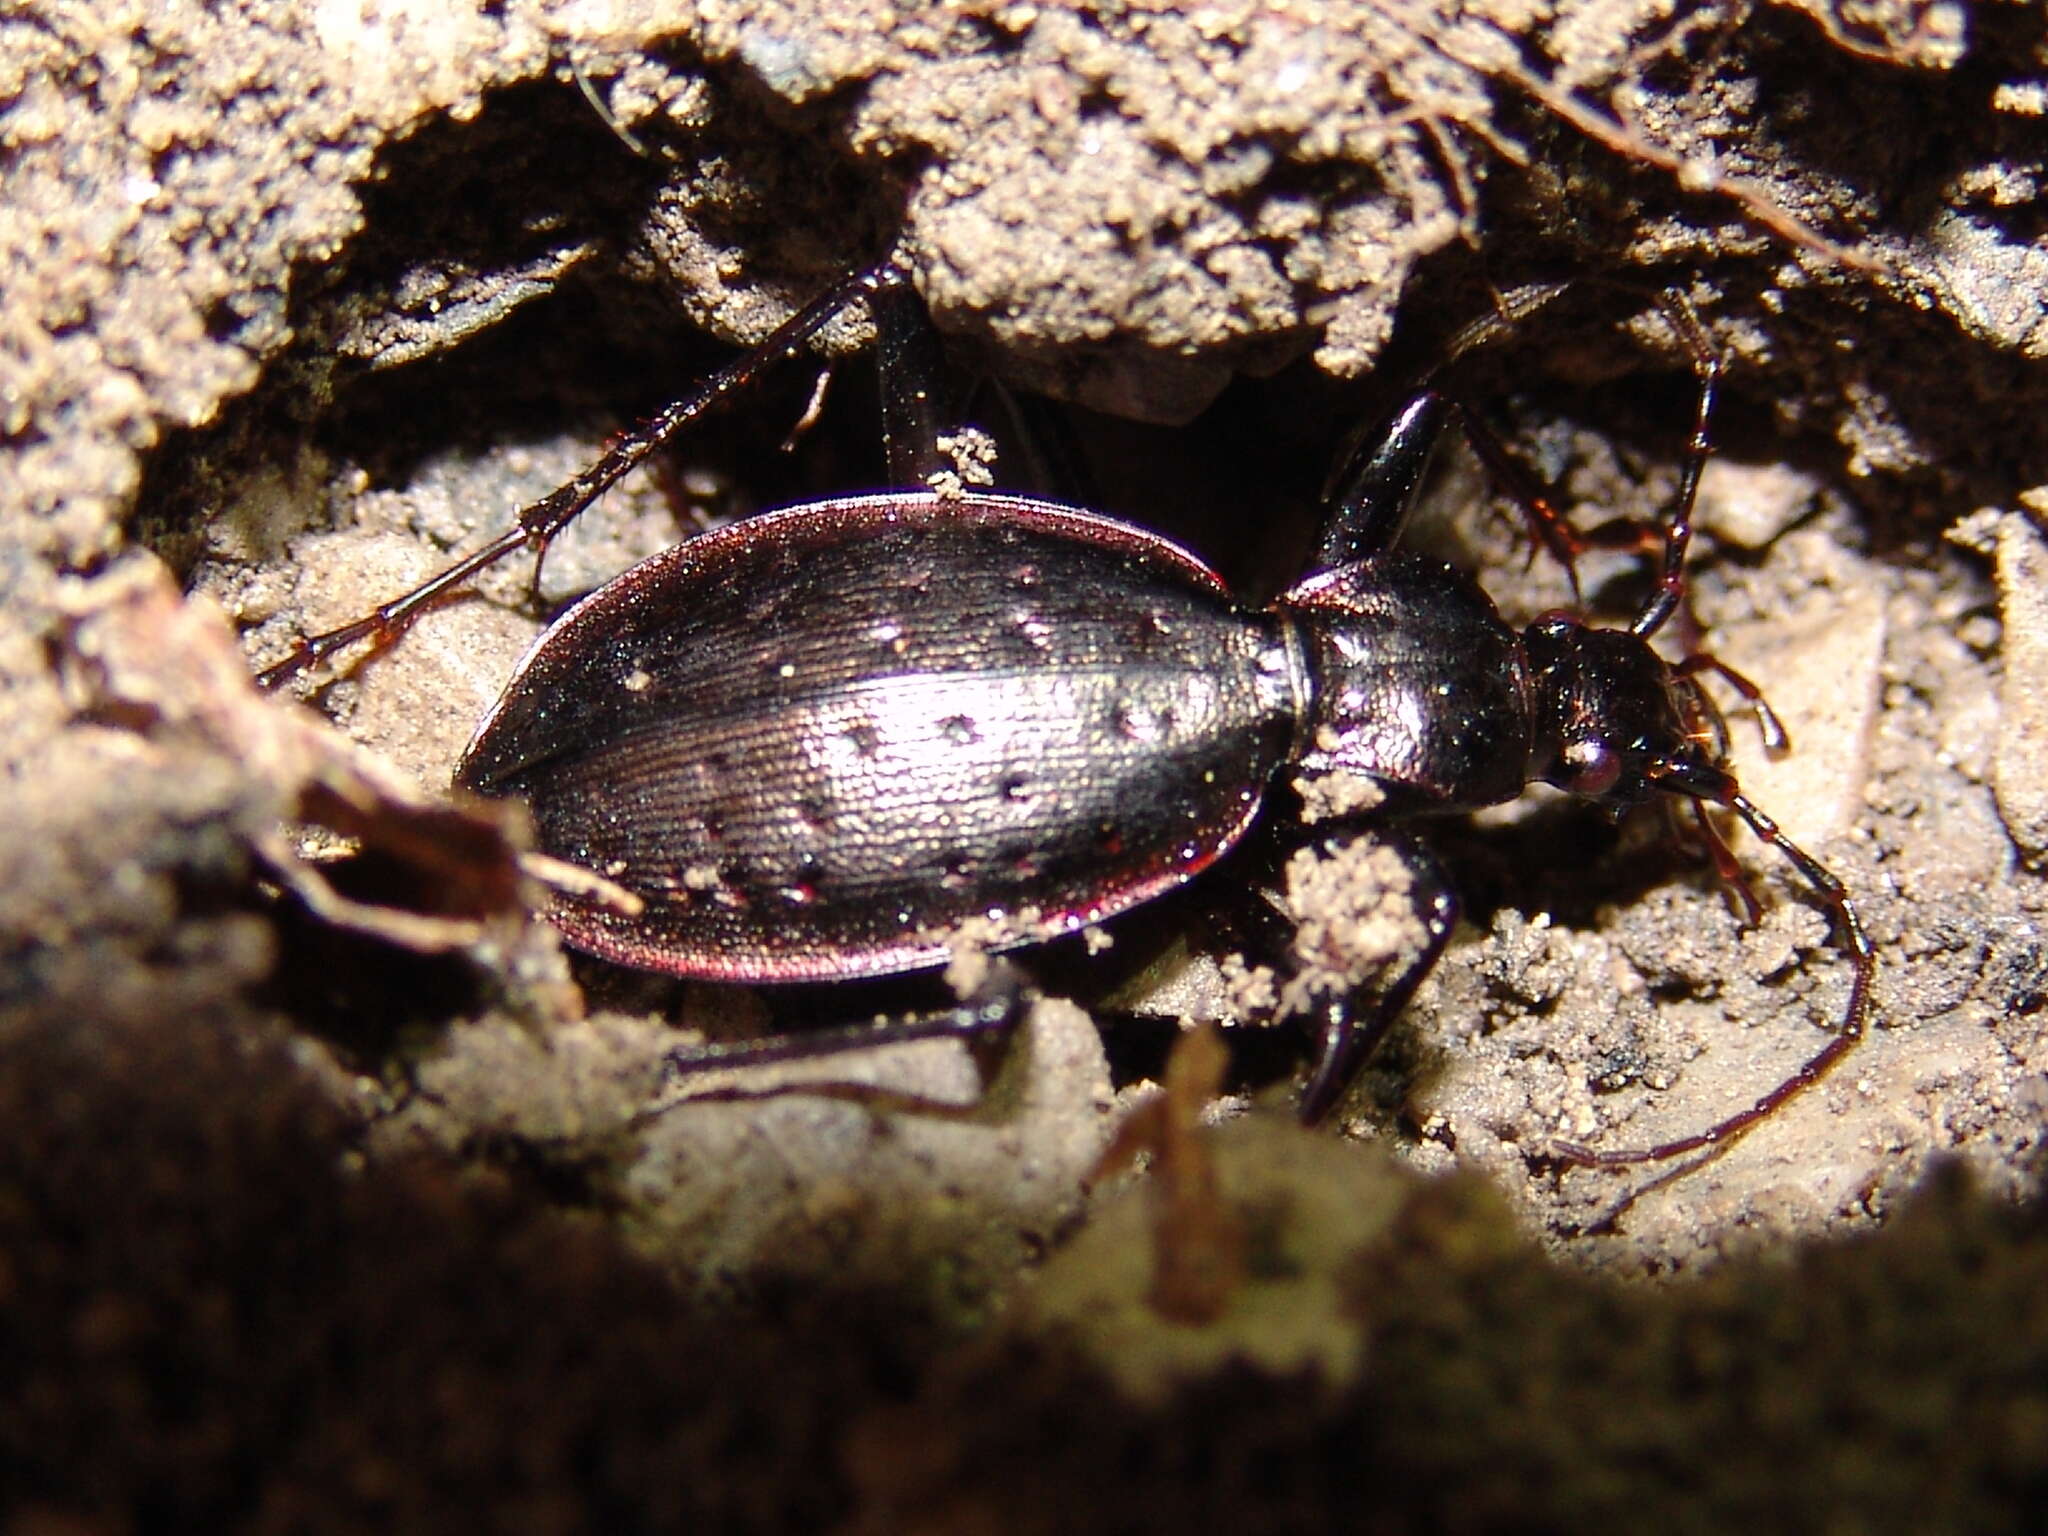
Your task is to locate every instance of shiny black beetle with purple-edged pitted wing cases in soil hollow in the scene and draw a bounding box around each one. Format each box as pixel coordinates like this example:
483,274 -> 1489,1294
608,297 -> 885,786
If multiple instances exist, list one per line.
262,260 -> 1876,1163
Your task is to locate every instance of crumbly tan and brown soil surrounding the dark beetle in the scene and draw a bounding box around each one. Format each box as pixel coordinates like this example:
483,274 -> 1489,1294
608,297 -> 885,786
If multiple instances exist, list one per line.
0,0 -> 2048,1530
